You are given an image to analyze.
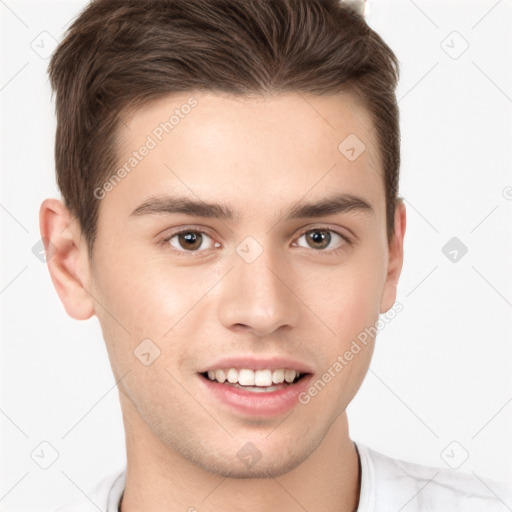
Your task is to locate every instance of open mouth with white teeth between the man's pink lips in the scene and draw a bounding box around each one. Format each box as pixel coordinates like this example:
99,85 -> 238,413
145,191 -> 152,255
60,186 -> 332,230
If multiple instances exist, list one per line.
199,368 -> 309,393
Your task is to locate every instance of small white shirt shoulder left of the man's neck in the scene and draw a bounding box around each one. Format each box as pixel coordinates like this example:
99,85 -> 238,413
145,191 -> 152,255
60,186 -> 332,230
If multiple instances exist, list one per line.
54,468 -> 126,512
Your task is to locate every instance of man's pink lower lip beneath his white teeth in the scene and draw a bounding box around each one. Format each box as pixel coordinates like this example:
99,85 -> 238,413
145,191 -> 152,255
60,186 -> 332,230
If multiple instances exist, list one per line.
199,374 -> 312,417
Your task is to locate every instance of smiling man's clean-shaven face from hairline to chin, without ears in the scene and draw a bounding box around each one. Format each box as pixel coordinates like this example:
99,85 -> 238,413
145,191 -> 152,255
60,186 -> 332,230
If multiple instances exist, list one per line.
80,93 -> 401,478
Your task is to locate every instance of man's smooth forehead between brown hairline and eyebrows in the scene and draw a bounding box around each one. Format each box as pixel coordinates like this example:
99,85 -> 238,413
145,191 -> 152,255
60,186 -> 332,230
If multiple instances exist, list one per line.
111,92 -> 384,216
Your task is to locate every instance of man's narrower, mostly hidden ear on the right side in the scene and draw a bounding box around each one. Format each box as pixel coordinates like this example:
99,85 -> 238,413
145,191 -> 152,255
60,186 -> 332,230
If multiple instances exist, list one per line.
380,198 -> 406,313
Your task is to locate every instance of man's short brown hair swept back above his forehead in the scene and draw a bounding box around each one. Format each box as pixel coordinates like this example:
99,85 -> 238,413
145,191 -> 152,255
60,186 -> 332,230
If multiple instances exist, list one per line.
48,0 -> 400,254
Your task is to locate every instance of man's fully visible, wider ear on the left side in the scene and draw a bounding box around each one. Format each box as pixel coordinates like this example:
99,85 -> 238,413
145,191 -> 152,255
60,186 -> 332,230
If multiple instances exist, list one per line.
39,199 -> 94,320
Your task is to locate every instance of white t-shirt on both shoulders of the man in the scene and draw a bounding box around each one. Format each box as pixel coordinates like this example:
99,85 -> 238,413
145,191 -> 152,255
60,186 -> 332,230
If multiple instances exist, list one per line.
55,441 -> 512,512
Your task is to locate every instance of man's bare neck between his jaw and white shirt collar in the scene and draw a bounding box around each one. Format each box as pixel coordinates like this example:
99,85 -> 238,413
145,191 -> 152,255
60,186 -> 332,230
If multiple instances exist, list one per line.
120,394 -> 361,512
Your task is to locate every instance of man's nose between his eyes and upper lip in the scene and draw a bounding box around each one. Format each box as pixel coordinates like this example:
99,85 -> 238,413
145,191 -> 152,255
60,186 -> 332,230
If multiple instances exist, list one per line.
218,242 -> 300,337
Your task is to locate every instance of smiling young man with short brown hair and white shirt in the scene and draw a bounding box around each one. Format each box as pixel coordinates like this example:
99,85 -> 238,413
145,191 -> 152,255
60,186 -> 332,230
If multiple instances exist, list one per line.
40,0 -> 512,512
